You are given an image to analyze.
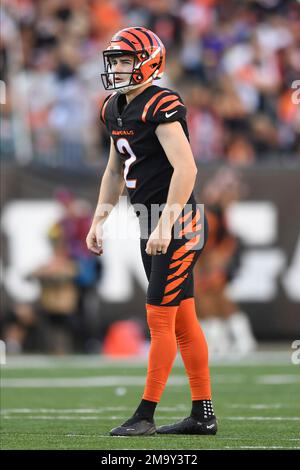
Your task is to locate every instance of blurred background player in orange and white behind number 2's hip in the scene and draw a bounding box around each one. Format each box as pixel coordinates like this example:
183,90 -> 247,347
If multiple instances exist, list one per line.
194,168 -> 256,357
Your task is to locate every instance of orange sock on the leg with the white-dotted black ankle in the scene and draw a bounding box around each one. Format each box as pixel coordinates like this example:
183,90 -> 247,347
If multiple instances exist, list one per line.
175,298 -> 211,400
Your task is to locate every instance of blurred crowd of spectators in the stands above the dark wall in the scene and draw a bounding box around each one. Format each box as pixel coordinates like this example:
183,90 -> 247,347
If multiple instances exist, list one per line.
0,0 -> 300,168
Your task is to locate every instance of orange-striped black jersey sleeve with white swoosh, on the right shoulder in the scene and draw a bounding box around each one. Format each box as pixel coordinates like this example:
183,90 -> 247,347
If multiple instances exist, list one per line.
142,90 -> 186,125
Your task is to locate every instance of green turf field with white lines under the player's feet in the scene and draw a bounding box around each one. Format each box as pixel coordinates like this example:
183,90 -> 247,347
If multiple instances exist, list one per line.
1,353 -> 300,450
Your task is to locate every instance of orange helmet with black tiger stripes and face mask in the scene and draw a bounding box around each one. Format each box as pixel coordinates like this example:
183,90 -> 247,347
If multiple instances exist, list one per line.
101,27 -> 166,93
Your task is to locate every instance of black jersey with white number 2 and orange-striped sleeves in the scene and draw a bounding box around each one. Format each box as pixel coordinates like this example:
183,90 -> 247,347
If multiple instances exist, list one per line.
101,85 -> 195,207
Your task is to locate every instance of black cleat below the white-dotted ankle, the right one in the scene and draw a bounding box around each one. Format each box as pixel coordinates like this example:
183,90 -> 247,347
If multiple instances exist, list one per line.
156,416 -> 218,435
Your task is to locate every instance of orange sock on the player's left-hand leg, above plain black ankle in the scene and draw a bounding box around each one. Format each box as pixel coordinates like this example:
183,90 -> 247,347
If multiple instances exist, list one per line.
143,304 -> 178,403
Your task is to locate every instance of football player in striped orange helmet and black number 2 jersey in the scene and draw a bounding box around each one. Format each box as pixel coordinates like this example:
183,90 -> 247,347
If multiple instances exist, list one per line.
87,27 -> 217,436
